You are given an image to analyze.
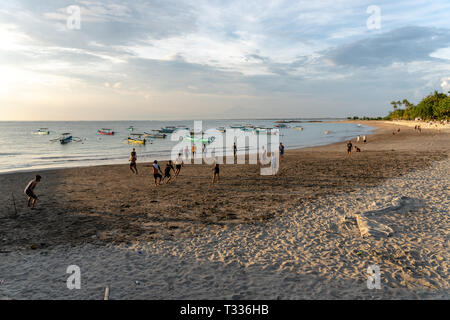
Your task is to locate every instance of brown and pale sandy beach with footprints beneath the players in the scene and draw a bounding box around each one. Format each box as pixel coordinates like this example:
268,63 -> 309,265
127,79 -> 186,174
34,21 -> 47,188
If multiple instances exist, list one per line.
0,121 -> 450,299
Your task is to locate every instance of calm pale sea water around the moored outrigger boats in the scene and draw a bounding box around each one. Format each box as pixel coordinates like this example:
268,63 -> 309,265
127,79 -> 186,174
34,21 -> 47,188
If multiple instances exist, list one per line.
0,119 -> 373,173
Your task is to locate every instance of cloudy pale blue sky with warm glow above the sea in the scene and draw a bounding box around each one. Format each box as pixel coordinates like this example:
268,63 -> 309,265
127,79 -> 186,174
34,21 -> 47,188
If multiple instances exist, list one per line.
0,0 -> 450,121
